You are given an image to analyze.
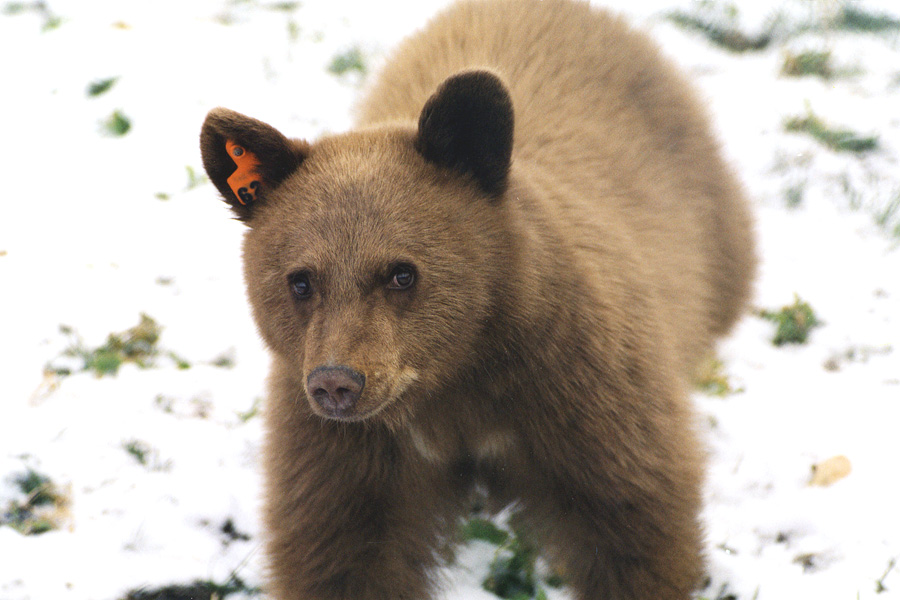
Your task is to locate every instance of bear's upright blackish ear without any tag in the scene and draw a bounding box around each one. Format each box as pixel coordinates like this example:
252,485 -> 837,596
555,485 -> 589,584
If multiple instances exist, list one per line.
416,70 -> 513,196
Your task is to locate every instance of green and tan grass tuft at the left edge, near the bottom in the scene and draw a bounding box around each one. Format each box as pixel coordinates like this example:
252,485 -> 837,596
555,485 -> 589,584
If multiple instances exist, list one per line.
0,468 -> 68,535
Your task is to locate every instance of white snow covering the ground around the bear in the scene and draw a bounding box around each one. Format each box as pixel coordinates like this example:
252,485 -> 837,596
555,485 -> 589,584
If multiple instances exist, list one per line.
0,0 -> 900,600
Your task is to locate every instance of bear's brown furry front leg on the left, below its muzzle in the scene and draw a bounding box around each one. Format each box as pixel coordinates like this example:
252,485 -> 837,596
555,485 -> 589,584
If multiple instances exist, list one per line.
265,418 -> 446,600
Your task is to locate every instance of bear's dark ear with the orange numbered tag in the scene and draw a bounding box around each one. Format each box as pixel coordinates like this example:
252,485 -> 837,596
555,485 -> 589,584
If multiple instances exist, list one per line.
200,108 -> 309,222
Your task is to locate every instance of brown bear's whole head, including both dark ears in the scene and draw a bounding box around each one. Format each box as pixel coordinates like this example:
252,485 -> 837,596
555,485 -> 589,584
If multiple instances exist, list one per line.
201,70 -> 513,421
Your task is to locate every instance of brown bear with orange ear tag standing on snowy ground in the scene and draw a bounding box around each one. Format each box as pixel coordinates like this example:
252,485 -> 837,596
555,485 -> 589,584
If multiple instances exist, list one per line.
200,0 -> 756,600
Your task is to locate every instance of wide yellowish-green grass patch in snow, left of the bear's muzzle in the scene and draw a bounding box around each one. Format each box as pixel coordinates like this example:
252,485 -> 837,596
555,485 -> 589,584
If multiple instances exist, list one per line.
45,314 -> 172,377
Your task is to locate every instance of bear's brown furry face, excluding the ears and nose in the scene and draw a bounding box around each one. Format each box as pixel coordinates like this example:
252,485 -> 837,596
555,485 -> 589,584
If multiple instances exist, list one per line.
244,132 -> 504,420
